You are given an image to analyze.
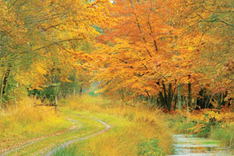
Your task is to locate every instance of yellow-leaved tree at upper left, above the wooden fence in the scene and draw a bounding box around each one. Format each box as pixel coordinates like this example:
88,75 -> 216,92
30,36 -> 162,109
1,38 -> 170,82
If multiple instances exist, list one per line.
2,0 -> 110,106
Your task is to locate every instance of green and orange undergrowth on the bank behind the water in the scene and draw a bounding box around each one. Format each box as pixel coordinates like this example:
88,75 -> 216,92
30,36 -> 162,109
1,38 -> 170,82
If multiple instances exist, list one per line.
169,108 -> 234,151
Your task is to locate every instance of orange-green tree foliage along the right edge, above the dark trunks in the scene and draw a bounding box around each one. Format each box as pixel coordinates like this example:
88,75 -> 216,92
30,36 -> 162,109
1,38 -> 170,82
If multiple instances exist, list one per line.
173,0 -> 234,108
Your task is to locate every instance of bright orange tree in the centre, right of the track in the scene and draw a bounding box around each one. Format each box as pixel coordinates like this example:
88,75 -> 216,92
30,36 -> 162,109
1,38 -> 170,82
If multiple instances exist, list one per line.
94,0 -> 184,109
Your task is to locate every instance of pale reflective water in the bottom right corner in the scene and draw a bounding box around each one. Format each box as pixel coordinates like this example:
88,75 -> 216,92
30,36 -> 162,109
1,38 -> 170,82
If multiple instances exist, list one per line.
170,135 -> 233,156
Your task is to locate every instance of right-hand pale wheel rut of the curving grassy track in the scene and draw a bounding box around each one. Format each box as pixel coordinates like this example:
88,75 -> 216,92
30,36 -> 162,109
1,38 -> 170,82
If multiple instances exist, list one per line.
46,119 -> 111,156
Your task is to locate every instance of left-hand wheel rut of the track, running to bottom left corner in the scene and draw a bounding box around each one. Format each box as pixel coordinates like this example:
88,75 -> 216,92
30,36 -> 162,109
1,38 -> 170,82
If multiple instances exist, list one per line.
0,119 -> 82,156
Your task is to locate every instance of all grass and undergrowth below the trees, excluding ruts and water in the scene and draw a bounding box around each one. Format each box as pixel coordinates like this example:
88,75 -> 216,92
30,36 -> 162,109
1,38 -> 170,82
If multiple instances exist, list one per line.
0,94 -> 234,156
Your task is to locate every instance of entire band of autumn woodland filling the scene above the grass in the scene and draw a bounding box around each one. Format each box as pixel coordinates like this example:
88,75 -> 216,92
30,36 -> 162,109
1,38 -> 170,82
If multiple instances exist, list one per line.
0,0 -> 234,111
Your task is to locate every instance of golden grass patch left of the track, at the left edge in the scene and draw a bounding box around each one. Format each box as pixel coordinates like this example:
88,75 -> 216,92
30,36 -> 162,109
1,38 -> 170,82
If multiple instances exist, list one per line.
0,98 -> 70,150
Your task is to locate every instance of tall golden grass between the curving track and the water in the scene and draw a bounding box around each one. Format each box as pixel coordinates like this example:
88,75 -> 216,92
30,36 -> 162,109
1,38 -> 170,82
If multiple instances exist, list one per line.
59,95 -> 173,156
